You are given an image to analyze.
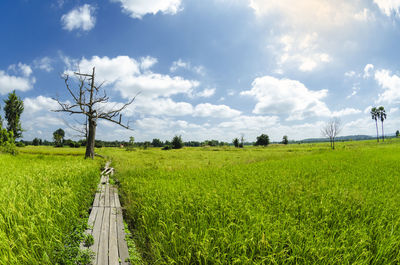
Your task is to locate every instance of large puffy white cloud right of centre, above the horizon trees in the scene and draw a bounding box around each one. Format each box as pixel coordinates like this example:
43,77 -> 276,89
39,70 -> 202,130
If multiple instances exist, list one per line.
240,76 -> 331,120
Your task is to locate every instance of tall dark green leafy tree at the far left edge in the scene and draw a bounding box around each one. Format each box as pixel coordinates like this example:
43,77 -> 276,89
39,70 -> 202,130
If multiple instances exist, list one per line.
4,90 -> 24,139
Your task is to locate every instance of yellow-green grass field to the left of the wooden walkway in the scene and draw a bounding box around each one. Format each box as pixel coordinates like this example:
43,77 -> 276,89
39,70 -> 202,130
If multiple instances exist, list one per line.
0,150 -> 100,264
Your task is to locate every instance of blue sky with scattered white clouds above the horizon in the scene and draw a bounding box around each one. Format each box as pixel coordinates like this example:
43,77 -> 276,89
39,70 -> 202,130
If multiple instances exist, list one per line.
0,0 -> 400,142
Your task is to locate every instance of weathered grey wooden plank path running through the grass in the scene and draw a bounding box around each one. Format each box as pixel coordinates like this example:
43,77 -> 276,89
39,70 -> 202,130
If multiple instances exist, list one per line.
82,162 -> 130,265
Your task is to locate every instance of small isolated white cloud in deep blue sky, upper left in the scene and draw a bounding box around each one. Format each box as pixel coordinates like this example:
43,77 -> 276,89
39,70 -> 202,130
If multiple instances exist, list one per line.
61,4 -> 96,31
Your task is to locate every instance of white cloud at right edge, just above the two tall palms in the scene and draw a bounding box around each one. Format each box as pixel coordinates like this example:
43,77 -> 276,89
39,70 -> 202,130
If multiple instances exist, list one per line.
375,69 -> 400,104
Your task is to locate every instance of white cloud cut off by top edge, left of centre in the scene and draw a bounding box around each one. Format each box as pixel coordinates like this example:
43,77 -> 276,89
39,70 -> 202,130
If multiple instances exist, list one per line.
111,0 -> 182,19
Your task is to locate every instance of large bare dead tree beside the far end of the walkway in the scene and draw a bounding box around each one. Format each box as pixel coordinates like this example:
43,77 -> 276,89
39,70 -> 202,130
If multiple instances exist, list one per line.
54,67 -> 135,159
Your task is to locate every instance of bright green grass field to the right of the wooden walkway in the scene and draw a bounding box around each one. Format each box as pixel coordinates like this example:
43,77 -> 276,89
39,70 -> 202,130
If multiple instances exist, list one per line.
101,140 -> 400,264
